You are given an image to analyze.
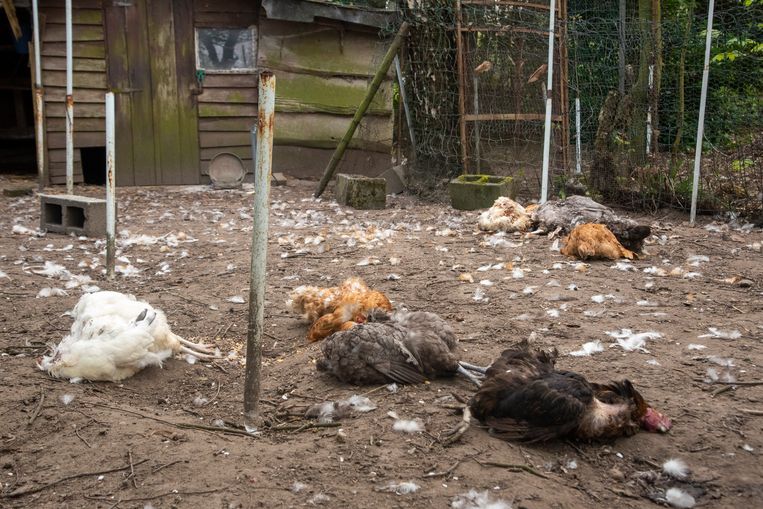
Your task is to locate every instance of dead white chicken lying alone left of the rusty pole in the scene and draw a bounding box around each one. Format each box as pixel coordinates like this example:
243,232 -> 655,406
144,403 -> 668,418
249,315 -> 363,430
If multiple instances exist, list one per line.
38,291 -> 219,382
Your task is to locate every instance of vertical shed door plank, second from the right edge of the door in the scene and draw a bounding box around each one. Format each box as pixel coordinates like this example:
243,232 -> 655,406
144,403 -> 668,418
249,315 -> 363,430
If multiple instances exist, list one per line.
146,0 -> 182,185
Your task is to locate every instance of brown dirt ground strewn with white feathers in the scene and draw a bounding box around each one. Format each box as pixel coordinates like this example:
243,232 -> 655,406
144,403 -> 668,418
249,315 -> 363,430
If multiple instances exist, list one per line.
0,173 -> 763,509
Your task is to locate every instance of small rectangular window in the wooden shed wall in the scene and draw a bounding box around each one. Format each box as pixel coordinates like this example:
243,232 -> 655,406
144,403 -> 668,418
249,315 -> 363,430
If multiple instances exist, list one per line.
196,28 -> 256,72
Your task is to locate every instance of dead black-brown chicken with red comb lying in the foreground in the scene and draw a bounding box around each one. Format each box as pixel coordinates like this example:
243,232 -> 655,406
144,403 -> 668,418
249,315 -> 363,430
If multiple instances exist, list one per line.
469,341 -> 672,442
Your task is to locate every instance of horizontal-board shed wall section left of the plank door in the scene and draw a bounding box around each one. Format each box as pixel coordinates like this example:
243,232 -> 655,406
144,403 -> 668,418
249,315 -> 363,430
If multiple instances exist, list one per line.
39,0 -> 106,184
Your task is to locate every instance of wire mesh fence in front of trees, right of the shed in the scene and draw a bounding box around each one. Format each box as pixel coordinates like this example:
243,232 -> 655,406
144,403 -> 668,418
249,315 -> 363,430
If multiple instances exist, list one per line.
384,0 -> 763,214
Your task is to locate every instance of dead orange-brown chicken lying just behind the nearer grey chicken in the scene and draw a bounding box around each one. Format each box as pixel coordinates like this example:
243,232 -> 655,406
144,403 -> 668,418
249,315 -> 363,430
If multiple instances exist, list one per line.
287,277 -> 392,341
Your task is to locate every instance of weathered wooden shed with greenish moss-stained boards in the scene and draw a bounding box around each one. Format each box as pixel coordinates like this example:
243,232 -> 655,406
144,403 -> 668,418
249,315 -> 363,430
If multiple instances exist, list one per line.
15,0 -> 393,185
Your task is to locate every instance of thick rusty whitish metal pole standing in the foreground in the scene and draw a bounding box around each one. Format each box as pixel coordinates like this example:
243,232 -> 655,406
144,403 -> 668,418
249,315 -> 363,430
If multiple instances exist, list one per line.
244,71 -> 276,431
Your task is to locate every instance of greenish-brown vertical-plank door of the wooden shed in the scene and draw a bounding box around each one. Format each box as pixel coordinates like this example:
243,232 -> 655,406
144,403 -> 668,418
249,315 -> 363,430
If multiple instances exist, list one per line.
105,0 -> 199,185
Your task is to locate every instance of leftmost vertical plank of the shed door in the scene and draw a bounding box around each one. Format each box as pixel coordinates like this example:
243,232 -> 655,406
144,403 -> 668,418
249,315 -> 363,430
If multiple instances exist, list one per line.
104,5 -> 135,186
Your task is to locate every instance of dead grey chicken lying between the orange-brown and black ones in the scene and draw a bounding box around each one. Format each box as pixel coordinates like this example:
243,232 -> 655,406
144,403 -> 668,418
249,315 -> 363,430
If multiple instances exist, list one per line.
317,310 -> 479,385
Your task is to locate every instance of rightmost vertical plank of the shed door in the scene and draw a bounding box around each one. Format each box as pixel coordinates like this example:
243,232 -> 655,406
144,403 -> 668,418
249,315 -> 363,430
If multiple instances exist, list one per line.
173,0 -> 200,184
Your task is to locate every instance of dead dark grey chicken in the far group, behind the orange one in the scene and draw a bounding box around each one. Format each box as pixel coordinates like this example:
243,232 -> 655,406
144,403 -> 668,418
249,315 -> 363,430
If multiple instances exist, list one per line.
532,196 -> 652,252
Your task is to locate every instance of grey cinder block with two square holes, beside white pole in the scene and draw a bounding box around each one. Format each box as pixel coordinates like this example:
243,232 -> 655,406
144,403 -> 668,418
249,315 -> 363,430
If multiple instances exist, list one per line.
40,194 -> 106,237
